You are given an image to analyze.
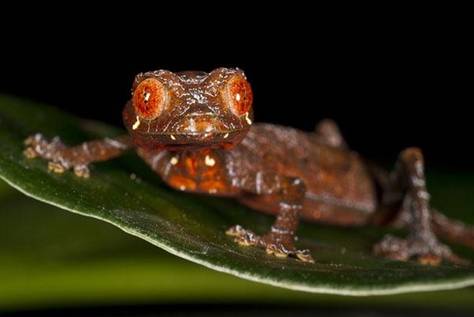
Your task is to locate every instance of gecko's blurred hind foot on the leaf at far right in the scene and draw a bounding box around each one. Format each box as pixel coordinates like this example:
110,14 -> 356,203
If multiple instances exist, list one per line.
373,235 -> 469,266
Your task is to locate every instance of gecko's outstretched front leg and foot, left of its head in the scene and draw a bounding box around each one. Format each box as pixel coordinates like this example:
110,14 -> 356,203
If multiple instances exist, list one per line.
24,133 -> 132,178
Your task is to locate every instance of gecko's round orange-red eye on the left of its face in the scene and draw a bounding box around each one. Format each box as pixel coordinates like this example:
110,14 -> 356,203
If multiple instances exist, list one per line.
132,78 -> 168,120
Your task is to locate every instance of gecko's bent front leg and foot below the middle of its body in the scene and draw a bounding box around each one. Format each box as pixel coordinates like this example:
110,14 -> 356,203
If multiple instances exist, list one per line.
226,173 -> 314,262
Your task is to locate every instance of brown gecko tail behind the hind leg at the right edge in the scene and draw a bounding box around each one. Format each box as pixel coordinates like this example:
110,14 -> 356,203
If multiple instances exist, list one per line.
431,209 -> 474,249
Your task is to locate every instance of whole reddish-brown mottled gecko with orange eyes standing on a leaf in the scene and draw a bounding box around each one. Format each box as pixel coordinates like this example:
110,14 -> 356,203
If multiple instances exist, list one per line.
25,68 -> 474,265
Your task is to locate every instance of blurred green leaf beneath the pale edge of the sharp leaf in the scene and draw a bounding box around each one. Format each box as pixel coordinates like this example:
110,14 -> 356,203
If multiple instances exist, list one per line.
0,189 -> 474,312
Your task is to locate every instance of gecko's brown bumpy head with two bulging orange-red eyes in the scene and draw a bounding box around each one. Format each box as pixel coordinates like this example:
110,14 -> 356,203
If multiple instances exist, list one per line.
123,68 -> 253,150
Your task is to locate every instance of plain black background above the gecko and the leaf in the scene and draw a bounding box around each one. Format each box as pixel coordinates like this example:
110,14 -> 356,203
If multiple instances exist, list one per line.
0,8 -> 474,170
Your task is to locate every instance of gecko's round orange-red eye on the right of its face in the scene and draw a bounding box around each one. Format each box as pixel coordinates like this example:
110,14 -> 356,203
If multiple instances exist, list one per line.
224,75 -> 253,116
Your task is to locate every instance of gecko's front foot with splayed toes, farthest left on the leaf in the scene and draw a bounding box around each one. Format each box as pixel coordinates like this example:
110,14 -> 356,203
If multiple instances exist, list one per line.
23,133 -> 90,178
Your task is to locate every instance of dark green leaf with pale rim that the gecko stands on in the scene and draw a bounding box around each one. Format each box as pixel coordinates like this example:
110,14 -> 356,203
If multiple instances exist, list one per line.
0,92 -> 474,295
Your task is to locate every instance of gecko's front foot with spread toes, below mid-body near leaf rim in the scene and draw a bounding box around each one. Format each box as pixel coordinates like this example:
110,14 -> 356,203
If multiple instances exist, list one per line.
226,225 -> 314,263
